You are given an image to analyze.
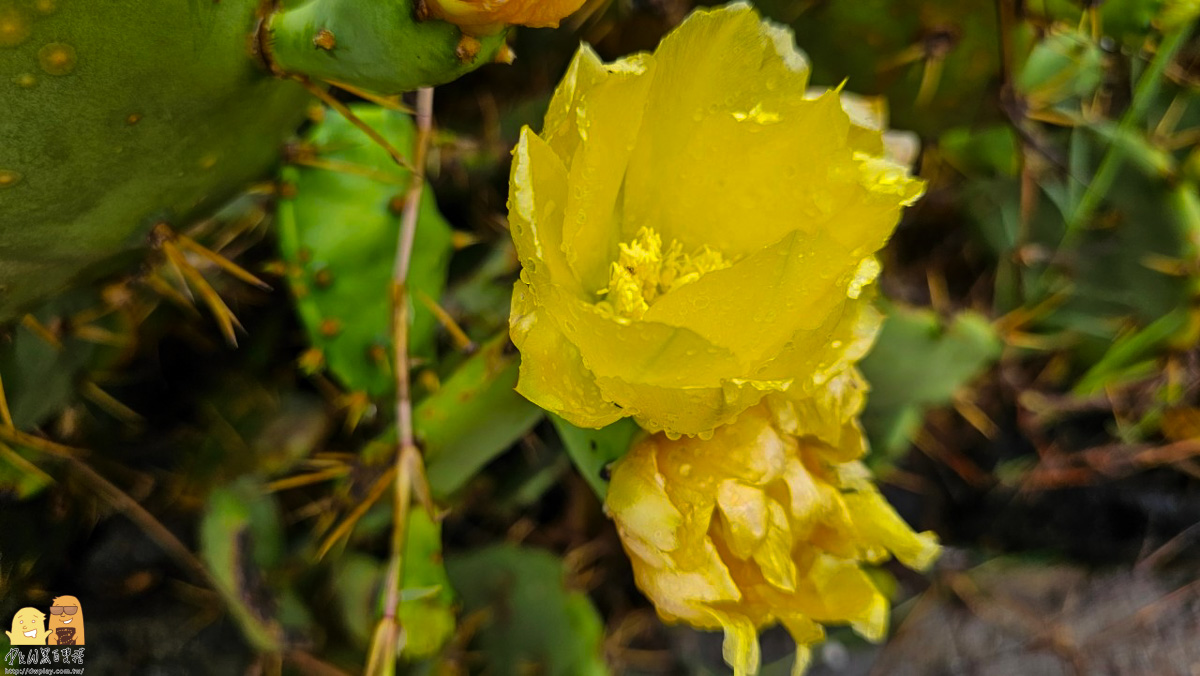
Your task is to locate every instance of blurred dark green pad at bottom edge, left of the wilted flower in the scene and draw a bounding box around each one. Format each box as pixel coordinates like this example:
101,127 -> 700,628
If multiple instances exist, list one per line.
446,545 -> 608,676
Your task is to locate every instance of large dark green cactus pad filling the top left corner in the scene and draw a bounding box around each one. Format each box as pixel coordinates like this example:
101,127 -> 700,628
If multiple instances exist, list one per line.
0,0 -> 307,322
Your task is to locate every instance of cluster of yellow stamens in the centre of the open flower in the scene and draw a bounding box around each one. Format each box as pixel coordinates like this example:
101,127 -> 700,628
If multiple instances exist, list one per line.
596,227 -> 733,319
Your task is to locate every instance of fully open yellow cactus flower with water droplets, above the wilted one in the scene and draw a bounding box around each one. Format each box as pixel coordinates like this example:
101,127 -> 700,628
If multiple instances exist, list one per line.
509,4 -> 923,437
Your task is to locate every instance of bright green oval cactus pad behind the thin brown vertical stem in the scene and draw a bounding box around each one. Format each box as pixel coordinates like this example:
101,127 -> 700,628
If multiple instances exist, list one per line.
278,106 -> 451,396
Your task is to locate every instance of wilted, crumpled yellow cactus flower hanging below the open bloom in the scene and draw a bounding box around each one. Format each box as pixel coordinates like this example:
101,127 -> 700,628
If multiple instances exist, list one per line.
606,396 -> 938,676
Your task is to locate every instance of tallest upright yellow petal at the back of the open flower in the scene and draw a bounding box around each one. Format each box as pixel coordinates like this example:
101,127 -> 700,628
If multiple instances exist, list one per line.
625,2 -> 825,255
